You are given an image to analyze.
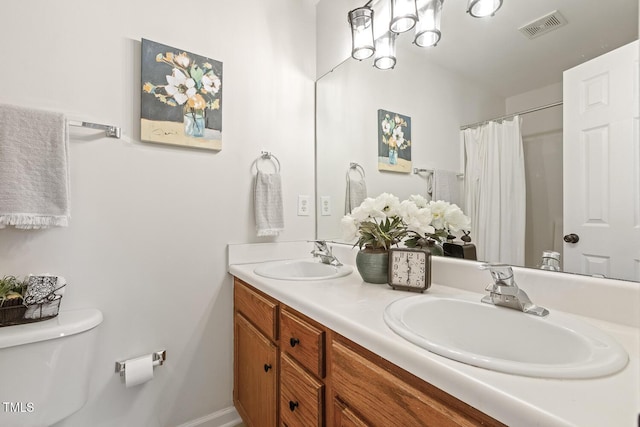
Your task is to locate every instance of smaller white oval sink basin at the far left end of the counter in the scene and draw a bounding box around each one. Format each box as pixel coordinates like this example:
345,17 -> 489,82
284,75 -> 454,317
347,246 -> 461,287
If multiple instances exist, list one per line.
253,259 -> 353,280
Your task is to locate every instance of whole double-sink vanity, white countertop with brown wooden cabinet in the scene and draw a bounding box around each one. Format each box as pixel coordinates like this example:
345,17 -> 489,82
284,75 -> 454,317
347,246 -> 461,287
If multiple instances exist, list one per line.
229,242 -> 640,426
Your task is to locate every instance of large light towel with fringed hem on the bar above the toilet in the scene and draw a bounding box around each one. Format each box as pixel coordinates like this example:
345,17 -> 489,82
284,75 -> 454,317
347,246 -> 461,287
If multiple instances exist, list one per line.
0,104 -> 69,229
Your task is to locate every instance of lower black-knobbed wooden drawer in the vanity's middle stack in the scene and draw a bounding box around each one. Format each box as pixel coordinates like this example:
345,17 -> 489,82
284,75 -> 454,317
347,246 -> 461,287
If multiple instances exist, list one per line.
280,353 -> 324,427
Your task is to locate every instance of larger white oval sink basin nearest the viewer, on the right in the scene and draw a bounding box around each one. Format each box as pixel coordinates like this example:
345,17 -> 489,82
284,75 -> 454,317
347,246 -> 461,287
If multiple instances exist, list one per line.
384,295 -> 628,379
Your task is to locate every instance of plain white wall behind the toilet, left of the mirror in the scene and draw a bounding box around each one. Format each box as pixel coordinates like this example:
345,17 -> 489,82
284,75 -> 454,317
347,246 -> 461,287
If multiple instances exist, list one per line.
0,0 -> 316,427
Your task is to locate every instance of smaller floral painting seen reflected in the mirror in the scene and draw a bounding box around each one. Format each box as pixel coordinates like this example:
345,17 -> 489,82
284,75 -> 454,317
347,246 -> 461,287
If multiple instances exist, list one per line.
378,110 -> 411,173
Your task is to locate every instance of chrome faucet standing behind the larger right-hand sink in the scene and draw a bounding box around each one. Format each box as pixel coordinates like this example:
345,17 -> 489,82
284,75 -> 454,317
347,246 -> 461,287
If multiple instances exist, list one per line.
480,264 -> 549,316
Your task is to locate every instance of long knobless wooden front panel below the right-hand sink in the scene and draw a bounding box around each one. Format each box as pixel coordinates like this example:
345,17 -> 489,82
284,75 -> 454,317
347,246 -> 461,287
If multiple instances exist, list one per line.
331,341 -> 502,427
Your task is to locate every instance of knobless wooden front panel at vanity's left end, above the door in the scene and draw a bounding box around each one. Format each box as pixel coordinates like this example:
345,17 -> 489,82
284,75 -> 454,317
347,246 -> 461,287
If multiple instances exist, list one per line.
233,278 -> 278,341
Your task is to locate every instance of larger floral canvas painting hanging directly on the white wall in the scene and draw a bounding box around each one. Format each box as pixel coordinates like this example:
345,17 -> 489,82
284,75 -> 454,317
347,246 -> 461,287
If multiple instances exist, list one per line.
140,39 -> 222,150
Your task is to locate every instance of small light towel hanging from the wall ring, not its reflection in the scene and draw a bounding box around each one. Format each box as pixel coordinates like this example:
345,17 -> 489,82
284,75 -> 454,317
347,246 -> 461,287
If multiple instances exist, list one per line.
254,171 -> 284,236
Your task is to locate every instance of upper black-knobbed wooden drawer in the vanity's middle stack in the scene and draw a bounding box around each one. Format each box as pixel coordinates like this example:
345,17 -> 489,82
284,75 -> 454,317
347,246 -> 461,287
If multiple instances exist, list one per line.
280,309 -> 325,378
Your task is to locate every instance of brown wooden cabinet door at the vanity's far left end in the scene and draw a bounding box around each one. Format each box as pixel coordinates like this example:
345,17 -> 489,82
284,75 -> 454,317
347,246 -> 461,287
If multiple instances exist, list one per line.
233,313 -> 278,427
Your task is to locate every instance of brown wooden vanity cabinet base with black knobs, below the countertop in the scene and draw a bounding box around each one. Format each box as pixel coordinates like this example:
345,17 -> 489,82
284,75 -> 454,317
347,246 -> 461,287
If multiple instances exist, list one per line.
234,279 -> 503,427
